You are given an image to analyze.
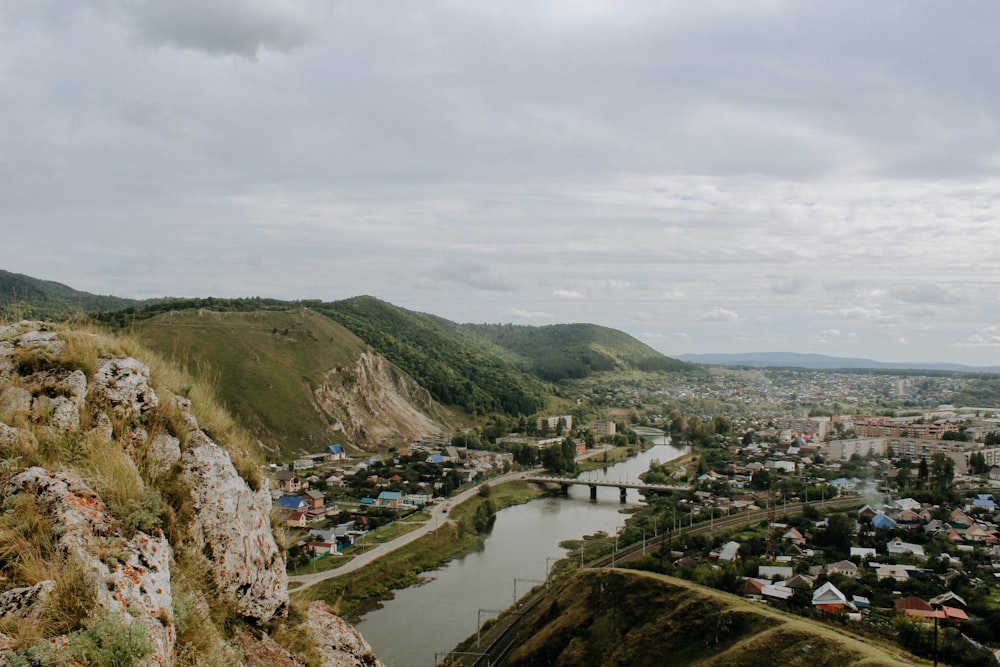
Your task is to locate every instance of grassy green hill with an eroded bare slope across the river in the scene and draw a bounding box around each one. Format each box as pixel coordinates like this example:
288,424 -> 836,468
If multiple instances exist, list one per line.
132,309 -> 452,460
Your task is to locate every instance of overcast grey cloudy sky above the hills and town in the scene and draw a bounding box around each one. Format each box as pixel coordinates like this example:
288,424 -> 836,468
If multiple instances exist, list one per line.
0,0 -> 1000,366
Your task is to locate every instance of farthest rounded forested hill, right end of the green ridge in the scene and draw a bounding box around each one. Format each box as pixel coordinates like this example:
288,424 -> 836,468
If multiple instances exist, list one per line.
463,324 -> 696,382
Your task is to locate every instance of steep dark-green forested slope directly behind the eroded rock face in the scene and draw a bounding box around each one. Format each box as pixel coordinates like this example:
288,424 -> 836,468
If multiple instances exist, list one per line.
313,296 -> 548,415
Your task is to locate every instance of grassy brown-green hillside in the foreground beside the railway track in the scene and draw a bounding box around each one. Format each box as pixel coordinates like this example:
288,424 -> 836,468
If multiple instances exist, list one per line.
496,570 -> 927,667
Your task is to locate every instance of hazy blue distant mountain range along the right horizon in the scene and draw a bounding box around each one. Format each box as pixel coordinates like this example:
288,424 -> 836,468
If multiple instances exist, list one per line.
674,352 -> 1000,373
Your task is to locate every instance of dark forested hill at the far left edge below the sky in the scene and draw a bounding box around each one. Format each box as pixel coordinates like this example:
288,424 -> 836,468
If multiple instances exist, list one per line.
0,269 -> 139,321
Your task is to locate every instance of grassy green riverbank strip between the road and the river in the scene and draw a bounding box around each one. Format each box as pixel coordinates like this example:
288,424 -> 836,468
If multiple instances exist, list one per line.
291,480 -> 544,622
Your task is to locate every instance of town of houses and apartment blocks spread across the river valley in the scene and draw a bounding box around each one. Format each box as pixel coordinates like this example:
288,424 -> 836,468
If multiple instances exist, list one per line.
270,371 -> 1000,664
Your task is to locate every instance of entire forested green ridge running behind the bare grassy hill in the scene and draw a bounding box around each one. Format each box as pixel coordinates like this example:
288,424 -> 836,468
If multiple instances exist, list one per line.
0,271 -> 696,415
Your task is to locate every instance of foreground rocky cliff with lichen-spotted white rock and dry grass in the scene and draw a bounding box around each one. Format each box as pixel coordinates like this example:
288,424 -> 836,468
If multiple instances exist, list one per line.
0,322 -> 378,667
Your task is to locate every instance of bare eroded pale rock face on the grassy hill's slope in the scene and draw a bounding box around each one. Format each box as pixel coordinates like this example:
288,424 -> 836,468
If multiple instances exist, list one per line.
313,352 -> 451,442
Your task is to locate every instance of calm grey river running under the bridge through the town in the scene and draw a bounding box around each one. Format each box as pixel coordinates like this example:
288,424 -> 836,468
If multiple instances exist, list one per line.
356,437 -> 684,667
